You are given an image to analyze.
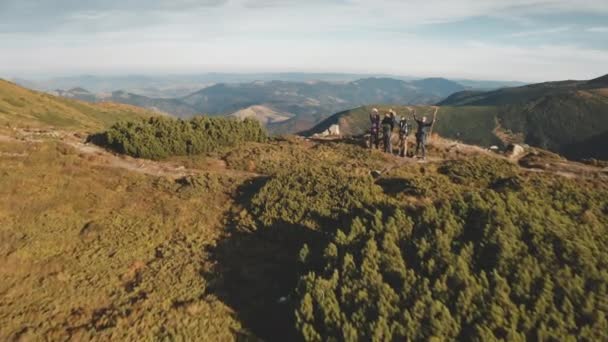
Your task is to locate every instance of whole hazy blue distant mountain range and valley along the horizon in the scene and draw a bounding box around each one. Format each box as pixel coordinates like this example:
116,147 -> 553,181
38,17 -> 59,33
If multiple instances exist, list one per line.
14,73 -> 521,134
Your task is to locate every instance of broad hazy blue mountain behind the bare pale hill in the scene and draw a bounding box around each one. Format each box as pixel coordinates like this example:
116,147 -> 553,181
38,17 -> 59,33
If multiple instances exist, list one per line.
176,78 -> 464,119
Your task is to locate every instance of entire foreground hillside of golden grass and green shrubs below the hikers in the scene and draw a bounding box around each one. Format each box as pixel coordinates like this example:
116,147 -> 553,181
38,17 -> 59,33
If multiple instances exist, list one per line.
0,125 -> 608,341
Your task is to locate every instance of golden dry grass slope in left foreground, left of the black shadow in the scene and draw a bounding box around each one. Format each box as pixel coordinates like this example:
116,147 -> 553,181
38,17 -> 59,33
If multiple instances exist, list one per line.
0,141 -> 254,340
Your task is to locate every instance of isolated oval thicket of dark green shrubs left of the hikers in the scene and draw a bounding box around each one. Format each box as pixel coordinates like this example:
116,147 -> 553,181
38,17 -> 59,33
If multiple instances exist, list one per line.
90,117 -> 267,159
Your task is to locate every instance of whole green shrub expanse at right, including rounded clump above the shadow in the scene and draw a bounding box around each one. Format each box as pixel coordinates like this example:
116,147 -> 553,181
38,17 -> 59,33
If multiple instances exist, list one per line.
233,157 -> 608,341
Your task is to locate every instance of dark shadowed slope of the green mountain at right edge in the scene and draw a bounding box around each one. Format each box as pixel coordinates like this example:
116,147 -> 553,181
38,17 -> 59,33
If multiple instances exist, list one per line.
440,75 -> 608,159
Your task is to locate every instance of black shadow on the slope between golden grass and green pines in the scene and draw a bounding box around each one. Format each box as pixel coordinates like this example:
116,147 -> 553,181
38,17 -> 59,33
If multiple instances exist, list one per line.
204,177 -> 319,341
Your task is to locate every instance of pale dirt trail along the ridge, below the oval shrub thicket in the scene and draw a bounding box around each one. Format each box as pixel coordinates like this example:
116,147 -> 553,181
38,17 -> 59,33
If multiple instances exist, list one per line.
0,129 -> 259,179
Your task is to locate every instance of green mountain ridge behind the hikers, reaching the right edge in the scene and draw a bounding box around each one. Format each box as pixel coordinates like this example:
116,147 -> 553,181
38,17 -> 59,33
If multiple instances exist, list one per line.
303,75 -> 608,159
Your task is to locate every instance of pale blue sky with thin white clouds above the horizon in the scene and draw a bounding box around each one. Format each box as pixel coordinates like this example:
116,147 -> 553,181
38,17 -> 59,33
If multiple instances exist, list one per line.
0,0 -> 608,82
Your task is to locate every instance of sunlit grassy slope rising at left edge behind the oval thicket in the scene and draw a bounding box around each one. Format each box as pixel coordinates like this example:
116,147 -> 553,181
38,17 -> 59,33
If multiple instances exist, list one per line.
0,80 -> 158,130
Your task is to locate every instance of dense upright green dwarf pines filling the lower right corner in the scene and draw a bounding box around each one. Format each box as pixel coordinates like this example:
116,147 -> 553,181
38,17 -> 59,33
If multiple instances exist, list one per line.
295,175 -> 608,341
